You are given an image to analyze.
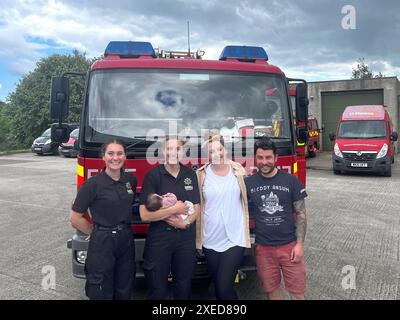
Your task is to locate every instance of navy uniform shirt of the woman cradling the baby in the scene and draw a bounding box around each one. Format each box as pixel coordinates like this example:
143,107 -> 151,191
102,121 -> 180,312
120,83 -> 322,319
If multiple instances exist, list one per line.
140,164 -> 200,230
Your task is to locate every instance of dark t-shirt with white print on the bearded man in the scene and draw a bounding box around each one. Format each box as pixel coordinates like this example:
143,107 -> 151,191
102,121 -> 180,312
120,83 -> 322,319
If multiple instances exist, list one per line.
245,170 -> 307,246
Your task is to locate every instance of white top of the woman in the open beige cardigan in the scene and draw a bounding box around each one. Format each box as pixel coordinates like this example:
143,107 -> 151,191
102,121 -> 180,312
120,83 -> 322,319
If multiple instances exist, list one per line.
202,165 -> 246,252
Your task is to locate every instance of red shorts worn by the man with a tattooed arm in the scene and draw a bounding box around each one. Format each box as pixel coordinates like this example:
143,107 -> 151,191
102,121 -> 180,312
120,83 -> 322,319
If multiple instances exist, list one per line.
255,241 -> 307,294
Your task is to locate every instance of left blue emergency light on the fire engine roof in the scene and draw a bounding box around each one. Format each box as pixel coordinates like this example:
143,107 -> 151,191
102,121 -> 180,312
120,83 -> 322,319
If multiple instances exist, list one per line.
104,41 -> 157,58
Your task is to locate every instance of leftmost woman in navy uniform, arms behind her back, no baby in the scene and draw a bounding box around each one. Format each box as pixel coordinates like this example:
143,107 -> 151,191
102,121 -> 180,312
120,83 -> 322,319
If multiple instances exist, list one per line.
71,139 -> 137,300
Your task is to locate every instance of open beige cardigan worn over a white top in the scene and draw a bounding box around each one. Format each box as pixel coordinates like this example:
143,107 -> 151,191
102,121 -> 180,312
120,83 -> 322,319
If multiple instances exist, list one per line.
196,160 -> 251,249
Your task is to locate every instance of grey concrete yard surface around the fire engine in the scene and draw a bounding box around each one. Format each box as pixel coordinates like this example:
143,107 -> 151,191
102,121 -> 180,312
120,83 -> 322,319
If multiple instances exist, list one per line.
0,153 -> 400,300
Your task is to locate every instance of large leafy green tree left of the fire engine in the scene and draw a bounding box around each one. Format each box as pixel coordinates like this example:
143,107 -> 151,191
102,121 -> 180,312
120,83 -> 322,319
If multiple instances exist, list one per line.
6,50 -> 92,147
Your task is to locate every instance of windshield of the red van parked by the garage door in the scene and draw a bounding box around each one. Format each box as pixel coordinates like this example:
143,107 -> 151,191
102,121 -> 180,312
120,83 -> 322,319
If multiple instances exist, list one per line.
338,120 -> 386,139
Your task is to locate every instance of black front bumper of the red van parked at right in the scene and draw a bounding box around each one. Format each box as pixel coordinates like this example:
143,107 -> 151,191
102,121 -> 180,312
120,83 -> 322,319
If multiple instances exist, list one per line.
332,154 -> 392,174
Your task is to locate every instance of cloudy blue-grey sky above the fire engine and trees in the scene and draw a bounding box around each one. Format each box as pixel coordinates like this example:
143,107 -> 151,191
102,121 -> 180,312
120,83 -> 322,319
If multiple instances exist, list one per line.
0,0 -> 400,101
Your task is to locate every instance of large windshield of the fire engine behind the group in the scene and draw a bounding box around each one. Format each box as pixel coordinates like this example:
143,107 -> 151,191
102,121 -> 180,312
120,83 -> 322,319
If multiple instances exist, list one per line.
85,69 -> 291,142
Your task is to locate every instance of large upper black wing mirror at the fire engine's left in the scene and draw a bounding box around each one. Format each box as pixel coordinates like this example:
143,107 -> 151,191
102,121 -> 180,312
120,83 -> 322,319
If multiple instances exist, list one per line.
50,77 -> 69,124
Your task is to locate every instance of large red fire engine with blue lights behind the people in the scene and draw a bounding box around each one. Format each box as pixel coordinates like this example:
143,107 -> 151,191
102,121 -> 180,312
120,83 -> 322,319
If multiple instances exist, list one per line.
51,41 -> 308,277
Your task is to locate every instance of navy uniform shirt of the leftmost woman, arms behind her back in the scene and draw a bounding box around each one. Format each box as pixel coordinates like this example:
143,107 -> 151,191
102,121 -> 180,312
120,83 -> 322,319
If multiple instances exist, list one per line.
72,169 -> 137,227
